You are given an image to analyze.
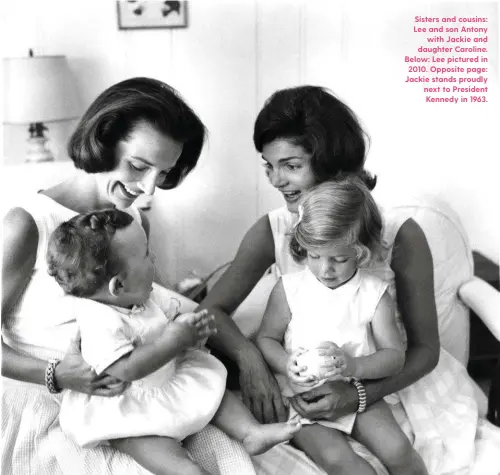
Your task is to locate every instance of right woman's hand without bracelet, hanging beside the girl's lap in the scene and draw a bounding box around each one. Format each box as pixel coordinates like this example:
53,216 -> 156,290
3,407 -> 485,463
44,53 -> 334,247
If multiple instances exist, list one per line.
237,349 -> 288,424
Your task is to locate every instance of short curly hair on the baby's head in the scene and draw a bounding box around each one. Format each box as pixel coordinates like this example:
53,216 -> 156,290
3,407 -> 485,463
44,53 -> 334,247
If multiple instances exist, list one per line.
46,209 -> 133,297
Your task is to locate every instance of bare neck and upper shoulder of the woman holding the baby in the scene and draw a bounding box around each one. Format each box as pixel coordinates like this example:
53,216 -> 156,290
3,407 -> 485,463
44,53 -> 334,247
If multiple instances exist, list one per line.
43,170 -> 114,213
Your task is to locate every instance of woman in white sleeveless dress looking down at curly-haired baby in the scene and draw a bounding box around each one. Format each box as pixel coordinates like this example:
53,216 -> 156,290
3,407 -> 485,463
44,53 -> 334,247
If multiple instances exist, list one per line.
2,78 -> 254,475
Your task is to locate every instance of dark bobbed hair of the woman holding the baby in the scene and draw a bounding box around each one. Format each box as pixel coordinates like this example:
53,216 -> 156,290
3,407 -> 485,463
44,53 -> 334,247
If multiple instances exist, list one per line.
68,78 -> 206,189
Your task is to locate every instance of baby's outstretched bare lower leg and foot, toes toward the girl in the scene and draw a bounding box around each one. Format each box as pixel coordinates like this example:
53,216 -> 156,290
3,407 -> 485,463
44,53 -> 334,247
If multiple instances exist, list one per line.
212,390 -> 300,455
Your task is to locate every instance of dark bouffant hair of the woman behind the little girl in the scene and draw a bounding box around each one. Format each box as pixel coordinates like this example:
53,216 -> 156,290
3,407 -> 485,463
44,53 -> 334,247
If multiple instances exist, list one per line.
253,86 -> 376,190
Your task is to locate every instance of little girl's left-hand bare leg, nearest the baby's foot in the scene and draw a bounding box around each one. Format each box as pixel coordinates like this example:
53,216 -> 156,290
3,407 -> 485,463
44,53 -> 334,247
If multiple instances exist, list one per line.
293,424 -> 376,475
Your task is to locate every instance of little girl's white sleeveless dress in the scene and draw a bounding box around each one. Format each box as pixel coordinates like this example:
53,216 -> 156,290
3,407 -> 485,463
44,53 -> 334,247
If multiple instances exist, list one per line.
278,268 -> 388,434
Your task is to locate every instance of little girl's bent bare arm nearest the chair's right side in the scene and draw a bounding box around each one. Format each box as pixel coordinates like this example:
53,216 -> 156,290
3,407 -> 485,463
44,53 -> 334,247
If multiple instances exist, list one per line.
320,292 -> 405,379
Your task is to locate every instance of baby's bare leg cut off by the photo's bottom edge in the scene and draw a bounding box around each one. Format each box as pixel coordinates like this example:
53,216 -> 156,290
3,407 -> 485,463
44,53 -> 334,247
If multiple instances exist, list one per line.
110,436 -> 210,475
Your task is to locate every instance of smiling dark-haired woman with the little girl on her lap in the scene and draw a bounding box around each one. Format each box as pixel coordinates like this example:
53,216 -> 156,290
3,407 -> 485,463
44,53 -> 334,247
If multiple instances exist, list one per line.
202,86 -> 439,450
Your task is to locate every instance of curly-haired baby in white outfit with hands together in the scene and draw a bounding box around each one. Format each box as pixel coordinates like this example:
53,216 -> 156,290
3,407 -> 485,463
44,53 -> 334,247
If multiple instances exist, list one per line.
47,210 -> 300,474
